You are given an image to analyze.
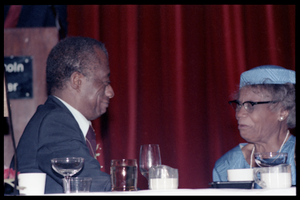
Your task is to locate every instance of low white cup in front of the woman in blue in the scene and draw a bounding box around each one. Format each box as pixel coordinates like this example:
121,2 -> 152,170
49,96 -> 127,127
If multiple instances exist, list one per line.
227,168 -> 254,181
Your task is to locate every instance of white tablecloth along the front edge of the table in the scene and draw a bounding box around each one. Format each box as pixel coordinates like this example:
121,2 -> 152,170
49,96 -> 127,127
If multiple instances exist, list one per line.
45,187 -> 296,196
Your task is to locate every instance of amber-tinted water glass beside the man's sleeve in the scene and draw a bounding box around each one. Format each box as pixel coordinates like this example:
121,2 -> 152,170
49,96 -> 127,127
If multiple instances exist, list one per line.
110,159 -> 138,191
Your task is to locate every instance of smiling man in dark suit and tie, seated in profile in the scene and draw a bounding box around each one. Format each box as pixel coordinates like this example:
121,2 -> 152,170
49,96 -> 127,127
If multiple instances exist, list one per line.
11,37 -> 114,193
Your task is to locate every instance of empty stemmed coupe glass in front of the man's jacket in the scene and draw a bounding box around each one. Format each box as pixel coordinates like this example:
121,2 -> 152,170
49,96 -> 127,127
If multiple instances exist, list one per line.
51,157 -> 84,193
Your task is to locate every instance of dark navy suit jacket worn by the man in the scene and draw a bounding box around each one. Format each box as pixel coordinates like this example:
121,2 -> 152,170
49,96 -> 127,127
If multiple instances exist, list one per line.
11,96 -> 111,193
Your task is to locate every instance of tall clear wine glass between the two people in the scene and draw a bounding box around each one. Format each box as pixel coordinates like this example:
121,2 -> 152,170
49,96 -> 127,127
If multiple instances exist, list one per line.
139,144 -> 161,180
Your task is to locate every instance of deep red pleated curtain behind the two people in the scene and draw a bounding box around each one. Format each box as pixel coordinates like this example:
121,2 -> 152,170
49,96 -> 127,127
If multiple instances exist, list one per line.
68,5 -> 295,189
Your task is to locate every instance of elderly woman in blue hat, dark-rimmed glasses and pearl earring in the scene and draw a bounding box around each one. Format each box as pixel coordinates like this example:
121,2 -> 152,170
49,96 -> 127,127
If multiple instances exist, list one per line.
213,65 -> 296,187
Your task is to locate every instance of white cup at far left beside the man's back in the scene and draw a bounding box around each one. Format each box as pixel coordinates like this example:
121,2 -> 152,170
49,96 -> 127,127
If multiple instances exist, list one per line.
18,173 -> 46,195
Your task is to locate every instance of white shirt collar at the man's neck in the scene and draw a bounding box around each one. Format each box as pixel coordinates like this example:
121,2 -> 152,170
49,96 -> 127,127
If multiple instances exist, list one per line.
55,96 -> 91,138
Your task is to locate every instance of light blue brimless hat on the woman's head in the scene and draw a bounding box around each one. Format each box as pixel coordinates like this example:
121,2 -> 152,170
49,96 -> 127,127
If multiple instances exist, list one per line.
240,65 -> 296,88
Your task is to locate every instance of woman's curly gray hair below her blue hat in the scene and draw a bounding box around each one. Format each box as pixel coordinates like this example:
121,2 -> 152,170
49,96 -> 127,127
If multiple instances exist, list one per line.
238,83 -> 296,128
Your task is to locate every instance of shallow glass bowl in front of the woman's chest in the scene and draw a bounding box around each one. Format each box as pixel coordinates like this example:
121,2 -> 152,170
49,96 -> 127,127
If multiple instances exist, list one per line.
254,152 -> 288,167
